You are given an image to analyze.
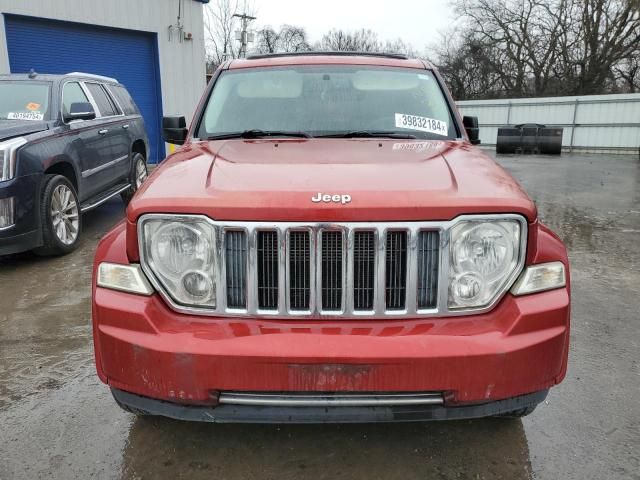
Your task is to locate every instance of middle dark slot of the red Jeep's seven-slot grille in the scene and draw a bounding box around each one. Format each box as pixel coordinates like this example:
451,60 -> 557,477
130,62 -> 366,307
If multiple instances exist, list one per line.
320,230 -> 344,311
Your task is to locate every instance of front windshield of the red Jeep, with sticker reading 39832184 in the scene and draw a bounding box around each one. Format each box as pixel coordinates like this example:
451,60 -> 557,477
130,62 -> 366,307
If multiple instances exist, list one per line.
198,65 -> 457,139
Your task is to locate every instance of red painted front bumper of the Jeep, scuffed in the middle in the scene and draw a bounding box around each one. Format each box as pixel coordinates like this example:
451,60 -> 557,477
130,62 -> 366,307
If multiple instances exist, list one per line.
93,288 -> 569,406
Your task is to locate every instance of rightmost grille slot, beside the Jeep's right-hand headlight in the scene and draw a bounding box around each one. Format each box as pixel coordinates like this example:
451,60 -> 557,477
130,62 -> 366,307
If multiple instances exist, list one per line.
417,231 -> 440,309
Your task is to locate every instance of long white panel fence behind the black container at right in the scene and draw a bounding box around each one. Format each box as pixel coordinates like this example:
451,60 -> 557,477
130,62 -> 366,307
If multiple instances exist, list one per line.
457,93 -> 640,154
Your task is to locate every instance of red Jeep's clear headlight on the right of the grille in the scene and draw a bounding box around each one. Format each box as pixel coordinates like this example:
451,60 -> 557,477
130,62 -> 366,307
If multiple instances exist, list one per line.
449,218 -> 526,310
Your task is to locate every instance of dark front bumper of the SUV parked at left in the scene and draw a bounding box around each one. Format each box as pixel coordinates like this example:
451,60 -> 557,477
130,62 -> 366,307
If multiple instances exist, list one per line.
0,174 -> 42,255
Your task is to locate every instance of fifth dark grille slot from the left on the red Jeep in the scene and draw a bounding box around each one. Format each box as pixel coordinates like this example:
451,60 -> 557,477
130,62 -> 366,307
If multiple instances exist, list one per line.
353,231 -> 376,311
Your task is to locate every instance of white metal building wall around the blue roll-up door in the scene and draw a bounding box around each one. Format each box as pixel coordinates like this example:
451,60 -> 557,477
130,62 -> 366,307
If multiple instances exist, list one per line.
0,0 -> 206,125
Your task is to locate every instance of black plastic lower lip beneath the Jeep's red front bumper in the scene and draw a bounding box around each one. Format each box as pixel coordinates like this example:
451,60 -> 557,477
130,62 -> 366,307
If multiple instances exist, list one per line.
112,389 -> 547,423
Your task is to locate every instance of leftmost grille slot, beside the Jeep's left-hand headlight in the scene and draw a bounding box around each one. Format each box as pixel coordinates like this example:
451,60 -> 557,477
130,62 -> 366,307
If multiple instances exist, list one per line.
225,230 -> 247,308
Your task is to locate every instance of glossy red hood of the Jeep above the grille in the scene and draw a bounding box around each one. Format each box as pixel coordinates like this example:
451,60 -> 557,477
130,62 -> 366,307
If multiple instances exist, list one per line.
128,139 -> 536,221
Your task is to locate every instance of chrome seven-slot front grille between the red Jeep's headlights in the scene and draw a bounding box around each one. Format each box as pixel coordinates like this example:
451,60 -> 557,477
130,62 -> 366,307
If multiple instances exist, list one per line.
214,223 -> 441,318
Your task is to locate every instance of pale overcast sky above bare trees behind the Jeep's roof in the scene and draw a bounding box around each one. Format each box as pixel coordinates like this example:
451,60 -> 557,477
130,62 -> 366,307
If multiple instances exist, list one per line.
245,0 -> 453,51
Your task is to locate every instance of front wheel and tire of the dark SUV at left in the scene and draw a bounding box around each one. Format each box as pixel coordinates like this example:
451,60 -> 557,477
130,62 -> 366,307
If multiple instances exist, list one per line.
34,175 -> 82,256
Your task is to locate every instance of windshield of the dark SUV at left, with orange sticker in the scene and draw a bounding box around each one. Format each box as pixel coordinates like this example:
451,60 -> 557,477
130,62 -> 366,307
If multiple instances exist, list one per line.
0,81 -> 51,121
